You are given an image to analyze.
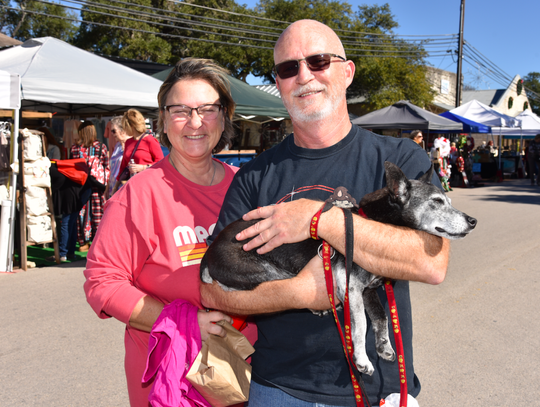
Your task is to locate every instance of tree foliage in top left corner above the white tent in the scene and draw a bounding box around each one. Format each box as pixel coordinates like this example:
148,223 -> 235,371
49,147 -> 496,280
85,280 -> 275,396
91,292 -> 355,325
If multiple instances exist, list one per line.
2,0 -> 77,42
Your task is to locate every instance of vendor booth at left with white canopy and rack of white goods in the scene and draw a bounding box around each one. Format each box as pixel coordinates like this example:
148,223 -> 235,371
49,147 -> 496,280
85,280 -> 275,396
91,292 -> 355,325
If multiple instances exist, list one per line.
0,37 -> 167,269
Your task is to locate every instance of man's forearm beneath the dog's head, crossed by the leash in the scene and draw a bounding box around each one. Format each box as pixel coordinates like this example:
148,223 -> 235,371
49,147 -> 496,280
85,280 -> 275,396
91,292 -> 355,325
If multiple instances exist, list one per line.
318,208 -> 450,284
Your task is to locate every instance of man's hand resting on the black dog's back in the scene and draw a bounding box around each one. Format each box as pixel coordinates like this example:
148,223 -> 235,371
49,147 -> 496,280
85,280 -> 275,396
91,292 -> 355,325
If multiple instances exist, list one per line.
236,199 -> 323,254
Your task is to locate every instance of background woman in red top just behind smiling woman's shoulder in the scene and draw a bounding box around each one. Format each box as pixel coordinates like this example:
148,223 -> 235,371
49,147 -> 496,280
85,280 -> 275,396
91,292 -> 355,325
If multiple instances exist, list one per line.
114,109 -> 163,191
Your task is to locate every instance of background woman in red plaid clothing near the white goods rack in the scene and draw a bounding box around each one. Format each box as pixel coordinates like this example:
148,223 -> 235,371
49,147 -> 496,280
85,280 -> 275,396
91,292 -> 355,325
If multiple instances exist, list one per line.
70,121 -> 110,251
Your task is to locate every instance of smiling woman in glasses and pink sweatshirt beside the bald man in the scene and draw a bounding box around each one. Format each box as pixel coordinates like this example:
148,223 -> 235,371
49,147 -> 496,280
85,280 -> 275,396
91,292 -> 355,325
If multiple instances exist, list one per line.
84,58 -> 255,407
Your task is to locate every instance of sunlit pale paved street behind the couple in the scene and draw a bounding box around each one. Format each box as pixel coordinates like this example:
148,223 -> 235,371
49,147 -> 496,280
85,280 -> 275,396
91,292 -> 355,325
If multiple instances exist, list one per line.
0,180 -> 540,407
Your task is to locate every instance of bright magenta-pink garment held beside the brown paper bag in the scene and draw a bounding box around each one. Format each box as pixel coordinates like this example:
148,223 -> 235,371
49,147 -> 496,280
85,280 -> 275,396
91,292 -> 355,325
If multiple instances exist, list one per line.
142,300 -> 211,407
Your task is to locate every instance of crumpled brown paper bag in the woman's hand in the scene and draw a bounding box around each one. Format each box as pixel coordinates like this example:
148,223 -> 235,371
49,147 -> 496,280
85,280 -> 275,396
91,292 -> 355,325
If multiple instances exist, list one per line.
186,321 -> 255,407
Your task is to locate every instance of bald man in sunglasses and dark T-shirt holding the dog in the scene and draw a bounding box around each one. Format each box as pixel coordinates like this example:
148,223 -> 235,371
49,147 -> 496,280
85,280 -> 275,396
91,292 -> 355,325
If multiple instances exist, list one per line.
201,20 -> 448,407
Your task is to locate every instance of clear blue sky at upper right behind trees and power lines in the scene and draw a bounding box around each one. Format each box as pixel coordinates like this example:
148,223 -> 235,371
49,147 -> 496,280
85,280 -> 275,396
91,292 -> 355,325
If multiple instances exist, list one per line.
243,0 -> 540,89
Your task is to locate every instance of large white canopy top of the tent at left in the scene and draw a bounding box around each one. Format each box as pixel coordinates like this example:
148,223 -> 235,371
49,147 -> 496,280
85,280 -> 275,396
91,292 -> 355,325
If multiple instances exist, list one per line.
0,37 -> 161,115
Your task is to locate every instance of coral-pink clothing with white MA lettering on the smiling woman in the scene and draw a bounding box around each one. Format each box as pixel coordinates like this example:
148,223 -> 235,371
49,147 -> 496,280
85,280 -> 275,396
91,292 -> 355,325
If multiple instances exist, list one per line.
84,157 -> 250,407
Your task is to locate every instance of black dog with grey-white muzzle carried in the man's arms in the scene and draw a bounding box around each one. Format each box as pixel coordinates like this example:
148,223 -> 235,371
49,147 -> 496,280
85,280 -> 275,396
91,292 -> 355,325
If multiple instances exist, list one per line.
200,162 -> 476,375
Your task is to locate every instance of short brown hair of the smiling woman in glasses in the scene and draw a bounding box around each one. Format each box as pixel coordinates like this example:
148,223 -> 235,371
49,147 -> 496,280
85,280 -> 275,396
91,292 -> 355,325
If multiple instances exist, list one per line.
157,58 -> 236,154
